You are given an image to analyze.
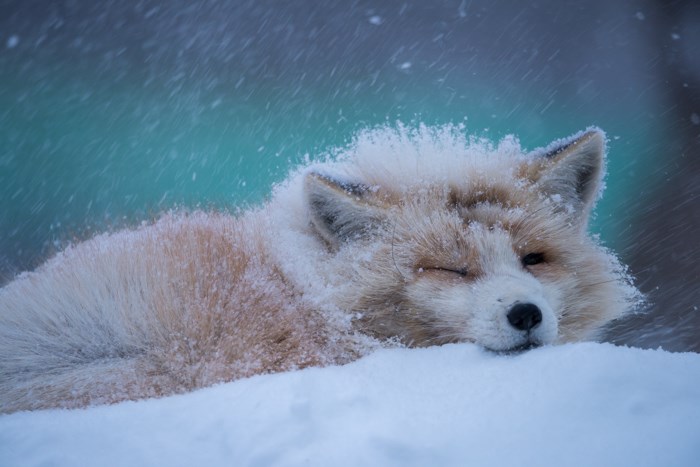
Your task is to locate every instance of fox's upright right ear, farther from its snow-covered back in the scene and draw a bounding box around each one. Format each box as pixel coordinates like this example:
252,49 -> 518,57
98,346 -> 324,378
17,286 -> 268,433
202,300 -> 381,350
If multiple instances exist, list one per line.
537,128 -> 605,225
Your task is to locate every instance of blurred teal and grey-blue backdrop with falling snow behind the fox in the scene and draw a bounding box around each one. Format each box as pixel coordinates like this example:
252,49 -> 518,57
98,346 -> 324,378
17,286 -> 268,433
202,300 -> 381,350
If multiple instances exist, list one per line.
0,0 -> 700,351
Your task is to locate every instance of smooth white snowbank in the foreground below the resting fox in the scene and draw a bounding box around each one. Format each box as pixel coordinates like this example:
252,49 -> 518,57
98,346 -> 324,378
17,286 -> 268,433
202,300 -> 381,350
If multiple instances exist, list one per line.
0,343 -> 700,467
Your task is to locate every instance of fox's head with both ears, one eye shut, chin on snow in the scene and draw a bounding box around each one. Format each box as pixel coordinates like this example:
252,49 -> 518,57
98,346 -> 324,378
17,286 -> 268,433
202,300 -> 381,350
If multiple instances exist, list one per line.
304,129 -> 634,351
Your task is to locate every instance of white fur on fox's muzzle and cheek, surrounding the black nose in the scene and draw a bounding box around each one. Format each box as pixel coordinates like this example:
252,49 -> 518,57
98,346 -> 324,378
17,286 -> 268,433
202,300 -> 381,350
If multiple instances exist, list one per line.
405,225 -> 560,351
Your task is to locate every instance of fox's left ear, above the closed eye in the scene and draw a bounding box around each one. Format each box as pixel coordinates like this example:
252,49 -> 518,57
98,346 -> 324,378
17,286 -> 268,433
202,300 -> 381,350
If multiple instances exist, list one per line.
304,172 -> 385,246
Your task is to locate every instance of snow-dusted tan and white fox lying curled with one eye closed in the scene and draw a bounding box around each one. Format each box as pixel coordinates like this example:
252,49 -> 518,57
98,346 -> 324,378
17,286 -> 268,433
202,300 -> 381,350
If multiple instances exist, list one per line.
0,125 -> 639,413
